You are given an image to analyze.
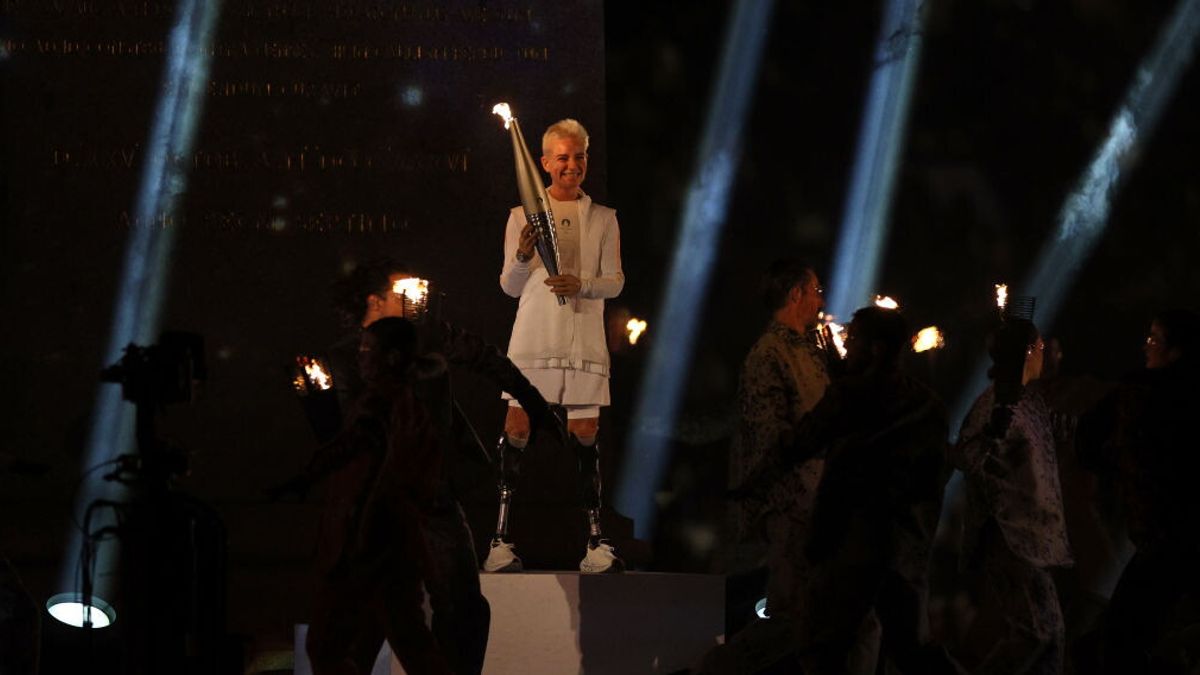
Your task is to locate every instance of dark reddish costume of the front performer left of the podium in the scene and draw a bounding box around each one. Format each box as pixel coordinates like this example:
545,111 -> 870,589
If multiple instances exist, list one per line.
304,362 -> 451,675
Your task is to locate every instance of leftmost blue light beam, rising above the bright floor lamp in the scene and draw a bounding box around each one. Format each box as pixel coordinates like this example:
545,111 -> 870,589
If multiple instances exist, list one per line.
60,0 -> 221,610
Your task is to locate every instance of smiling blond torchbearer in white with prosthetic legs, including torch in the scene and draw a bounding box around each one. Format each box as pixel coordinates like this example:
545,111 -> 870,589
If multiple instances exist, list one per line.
484,103 -> 625,573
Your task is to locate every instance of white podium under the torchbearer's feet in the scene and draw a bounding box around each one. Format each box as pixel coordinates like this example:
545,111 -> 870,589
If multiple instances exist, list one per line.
295,572 -> 725,675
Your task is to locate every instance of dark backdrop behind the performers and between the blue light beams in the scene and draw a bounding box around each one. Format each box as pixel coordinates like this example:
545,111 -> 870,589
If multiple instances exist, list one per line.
0,0 -> 1200,667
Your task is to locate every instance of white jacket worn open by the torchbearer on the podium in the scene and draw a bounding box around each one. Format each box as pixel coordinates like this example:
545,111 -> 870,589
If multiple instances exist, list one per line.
500,195 -> 625,377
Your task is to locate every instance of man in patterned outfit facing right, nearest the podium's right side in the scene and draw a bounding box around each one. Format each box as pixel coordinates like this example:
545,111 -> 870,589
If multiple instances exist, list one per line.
702,258 -> 876,674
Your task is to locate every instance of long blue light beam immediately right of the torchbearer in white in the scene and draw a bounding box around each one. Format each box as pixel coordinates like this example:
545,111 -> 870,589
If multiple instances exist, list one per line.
616,0 -> 773,538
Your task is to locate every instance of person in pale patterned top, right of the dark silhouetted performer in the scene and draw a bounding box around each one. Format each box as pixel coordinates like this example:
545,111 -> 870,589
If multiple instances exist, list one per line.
952,318 -> 1072,675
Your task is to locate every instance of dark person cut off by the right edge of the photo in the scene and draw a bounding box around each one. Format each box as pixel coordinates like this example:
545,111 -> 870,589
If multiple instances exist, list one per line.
1102,310 -> 1200,674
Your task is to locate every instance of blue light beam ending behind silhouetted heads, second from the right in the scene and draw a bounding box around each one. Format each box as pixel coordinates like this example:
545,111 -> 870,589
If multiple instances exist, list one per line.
828,0 -> 925,316
